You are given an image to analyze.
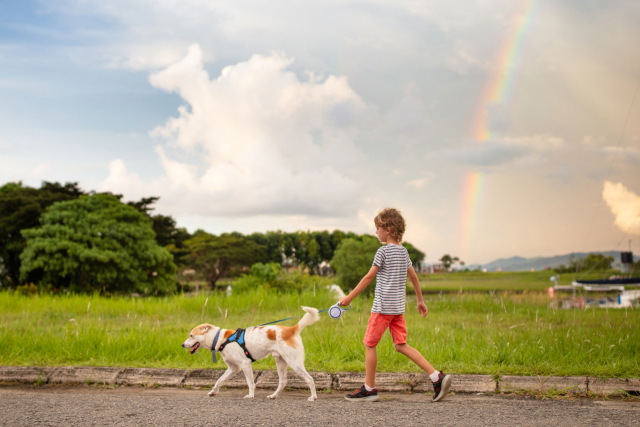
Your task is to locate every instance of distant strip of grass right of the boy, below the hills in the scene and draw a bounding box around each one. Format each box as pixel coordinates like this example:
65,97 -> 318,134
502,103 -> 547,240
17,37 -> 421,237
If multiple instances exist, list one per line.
418,270 -> 638,293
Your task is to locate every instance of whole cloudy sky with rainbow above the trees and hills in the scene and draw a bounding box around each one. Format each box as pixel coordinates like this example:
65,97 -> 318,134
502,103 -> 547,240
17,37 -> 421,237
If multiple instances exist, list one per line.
0,0 -> 640,265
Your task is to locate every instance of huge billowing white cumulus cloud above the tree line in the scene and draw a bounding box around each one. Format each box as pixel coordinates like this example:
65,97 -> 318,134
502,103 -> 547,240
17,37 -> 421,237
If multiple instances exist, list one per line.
101,44 -> 370,217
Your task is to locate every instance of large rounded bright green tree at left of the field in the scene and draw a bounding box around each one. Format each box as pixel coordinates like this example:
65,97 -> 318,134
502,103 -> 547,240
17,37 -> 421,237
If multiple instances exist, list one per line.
20,194 -> 176,293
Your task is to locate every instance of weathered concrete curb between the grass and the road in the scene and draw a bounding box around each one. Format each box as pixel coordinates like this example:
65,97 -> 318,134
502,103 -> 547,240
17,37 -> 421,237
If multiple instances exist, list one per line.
0,366 -> 640,395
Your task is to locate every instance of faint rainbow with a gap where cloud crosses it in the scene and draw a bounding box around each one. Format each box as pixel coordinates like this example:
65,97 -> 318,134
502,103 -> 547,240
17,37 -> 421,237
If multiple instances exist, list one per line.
462,0 -> 540,257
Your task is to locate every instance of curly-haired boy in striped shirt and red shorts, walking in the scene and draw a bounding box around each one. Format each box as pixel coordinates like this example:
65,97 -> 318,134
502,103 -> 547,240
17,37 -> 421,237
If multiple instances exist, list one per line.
339,208 -> 451,402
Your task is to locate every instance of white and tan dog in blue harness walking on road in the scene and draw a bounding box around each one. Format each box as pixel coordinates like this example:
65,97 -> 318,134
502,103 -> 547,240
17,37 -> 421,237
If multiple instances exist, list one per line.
182,307 -> 320,402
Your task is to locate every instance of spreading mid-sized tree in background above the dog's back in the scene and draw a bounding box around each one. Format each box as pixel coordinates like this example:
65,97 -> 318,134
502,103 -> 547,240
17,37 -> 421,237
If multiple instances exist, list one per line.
185,230 -> 264,289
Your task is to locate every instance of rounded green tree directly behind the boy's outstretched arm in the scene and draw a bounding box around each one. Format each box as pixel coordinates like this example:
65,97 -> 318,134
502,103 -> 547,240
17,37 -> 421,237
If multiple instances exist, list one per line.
331,236 -> 380,294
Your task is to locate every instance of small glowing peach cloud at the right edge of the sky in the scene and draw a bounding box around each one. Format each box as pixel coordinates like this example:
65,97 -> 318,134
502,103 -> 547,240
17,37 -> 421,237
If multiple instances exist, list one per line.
602,181 -> 640,234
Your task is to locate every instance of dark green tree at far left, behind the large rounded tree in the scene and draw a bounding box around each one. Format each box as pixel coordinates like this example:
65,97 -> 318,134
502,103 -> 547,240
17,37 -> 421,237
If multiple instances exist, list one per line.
0,182 -> 84,288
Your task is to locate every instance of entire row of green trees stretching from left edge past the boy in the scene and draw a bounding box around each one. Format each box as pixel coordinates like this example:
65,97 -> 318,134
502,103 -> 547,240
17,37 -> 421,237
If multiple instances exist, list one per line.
0,182 -> 425,294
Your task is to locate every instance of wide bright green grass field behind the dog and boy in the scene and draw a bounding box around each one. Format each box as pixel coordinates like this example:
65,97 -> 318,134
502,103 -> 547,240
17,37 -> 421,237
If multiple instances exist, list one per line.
0,290 -> 640,377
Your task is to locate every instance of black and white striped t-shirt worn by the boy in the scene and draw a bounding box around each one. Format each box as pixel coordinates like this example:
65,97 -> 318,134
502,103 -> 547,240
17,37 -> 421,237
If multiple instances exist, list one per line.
371,243 -> 411,314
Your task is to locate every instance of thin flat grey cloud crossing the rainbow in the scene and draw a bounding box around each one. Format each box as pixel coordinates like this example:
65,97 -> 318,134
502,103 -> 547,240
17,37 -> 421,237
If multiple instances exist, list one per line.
444,135 -> 564,166
